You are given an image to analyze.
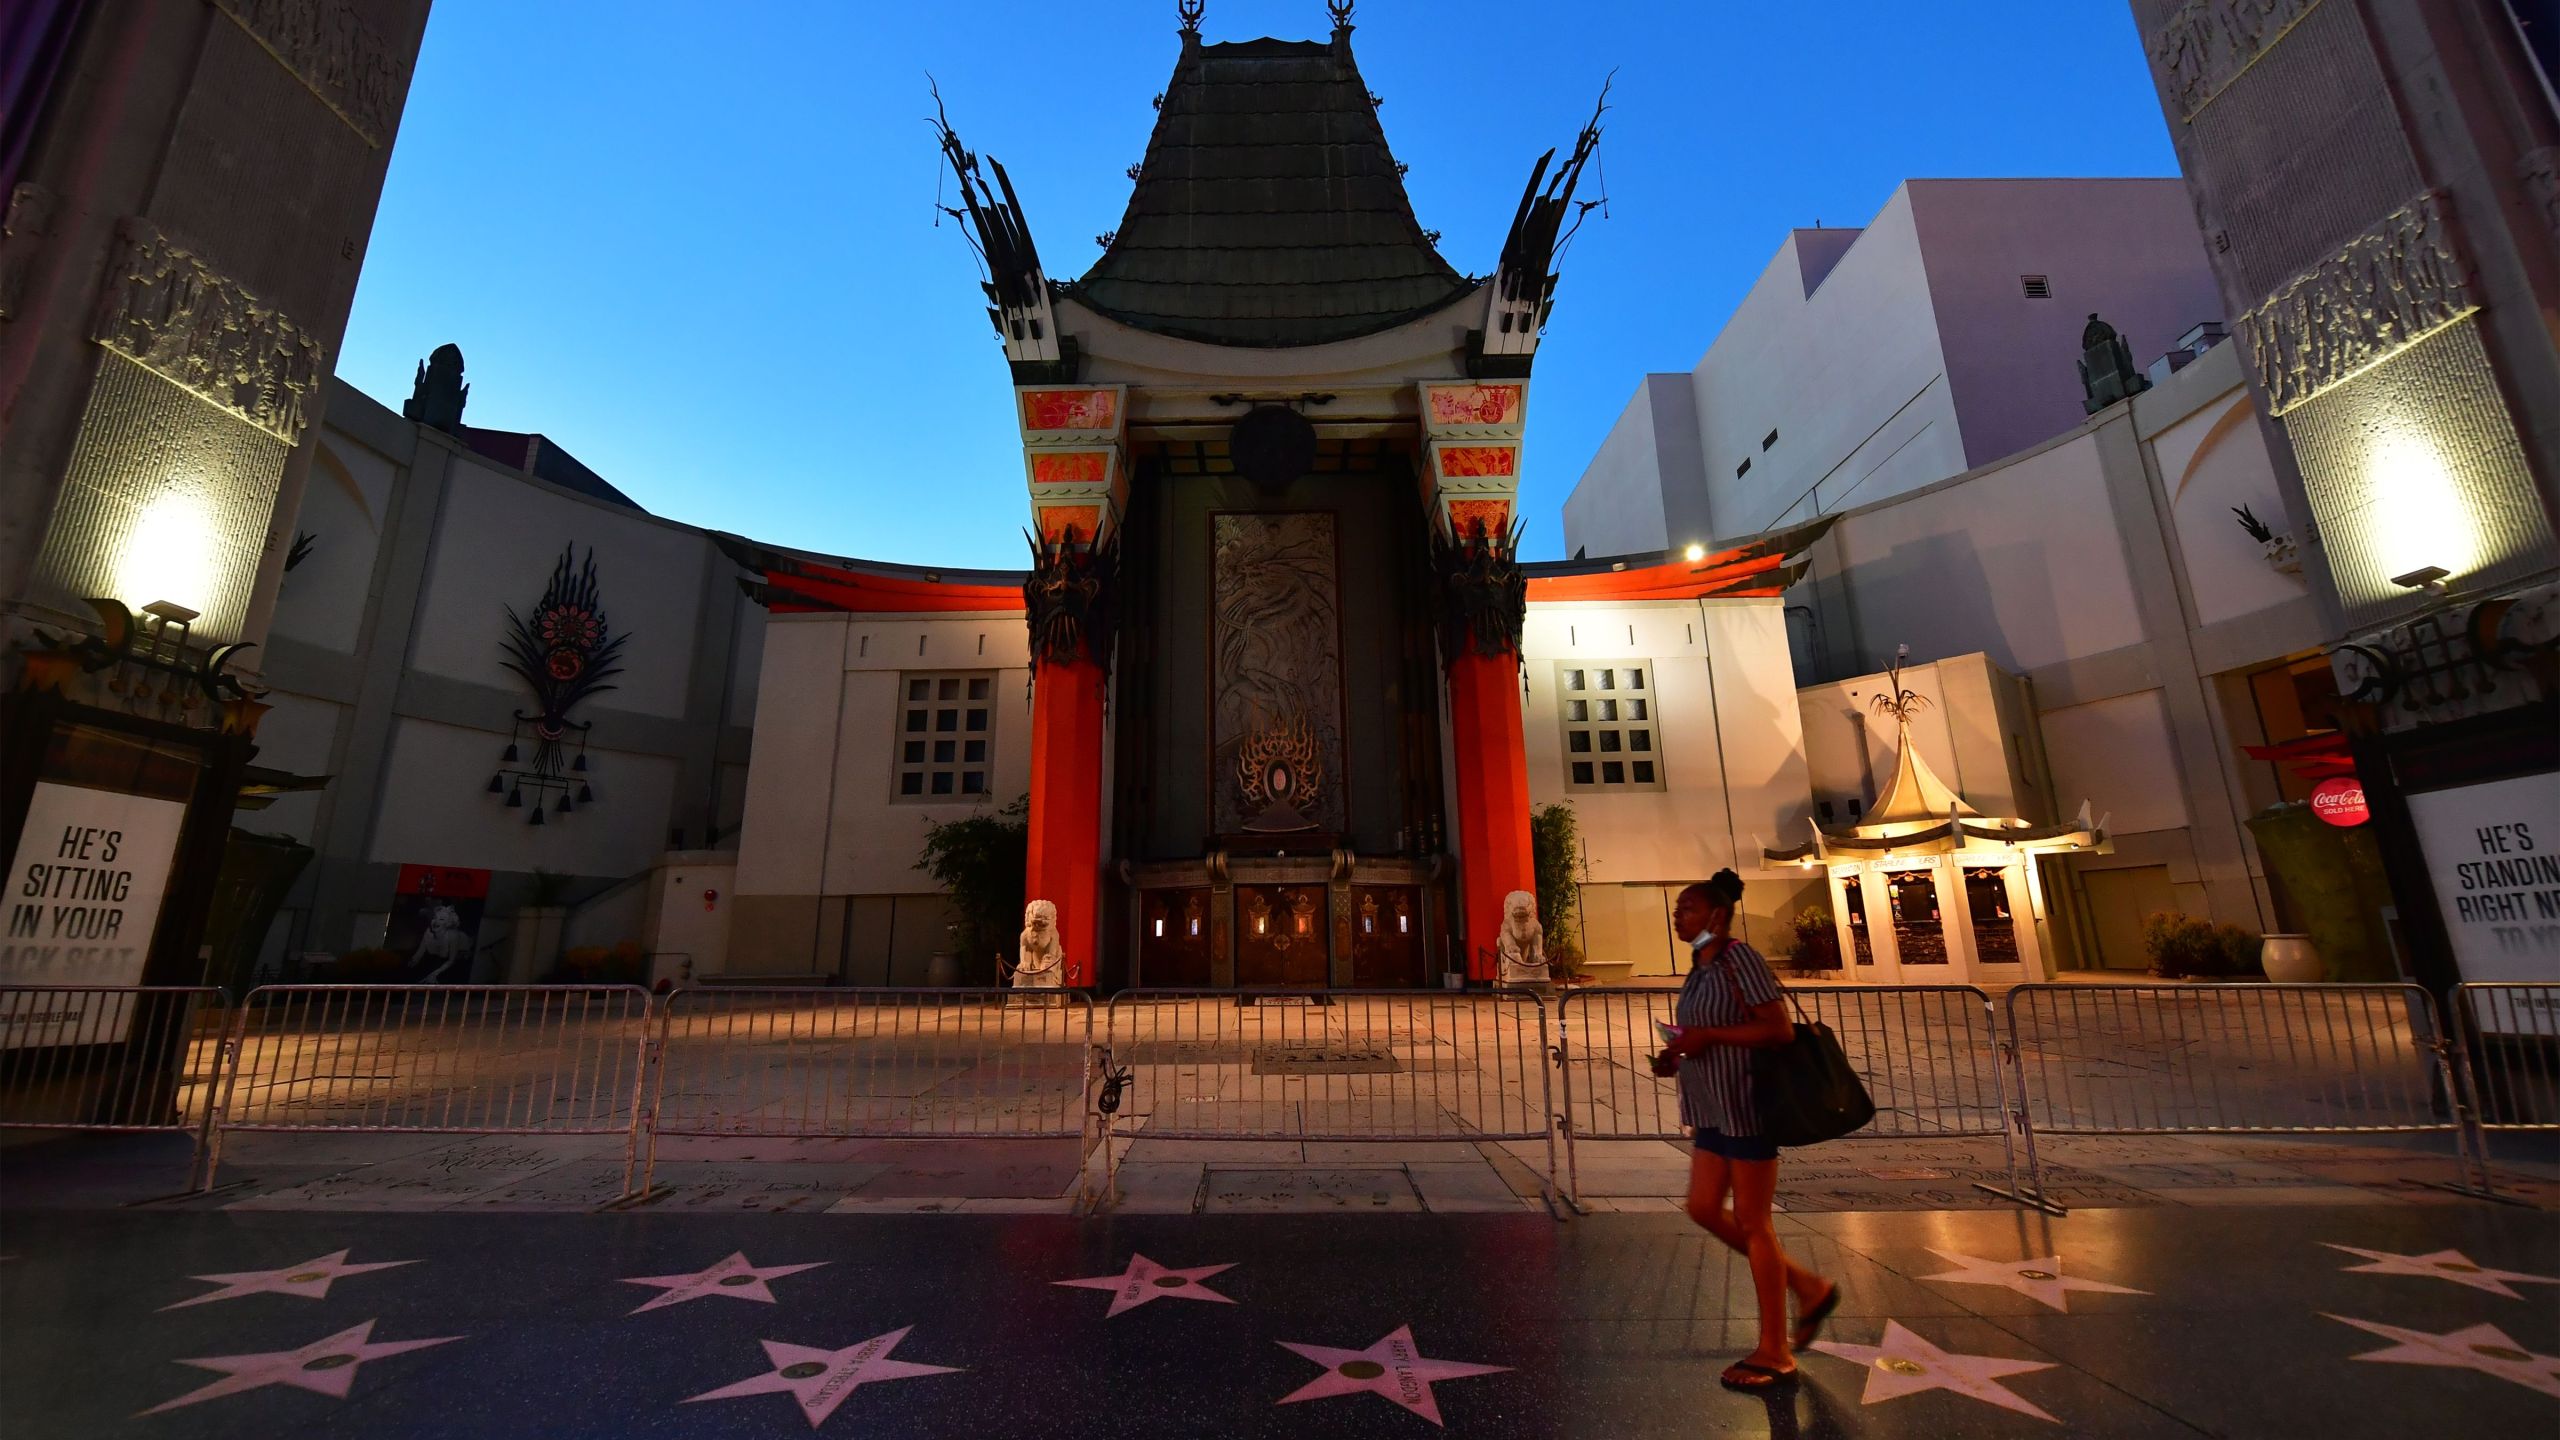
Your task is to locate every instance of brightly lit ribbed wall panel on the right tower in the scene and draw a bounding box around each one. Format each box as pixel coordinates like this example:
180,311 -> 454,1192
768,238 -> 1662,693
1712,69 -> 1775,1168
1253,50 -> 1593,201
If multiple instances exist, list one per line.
2284,320 -> 2552,625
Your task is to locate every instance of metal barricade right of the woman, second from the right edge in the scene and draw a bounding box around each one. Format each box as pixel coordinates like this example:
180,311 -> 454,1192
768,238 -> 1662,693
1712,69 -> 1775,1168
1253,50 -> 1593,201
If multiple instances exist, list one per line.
2007,984 -> 2468,1158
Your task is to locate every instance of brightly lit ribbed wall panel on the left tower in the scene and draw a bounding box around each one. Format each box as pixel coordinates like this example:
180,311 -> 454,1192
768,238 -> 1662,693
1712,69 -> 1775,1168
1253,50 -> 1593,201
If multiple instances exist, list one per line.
36,351 -> 287,643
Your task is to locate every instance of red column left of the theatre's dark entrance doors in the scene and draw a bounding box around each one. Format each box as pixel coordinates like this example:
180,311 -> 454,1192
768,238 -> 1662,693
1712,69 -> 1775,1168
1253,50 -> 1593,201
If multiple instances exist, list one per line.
1021,656 -> 1108,986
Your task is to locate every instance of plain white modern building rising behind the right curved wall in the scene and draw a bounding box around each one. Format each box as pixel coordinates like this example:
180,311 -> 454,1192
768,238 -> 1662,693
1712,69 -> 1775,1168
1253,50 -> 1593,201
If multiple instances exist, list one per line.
1564,179 -> 2222,556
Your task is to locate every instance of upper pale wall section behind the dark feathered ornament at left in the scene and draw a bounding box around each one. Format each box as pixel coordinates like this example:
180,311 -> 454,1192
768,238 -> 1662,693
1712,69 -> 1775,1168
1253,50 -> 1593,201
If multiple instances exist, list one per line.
410,456 -> 712,720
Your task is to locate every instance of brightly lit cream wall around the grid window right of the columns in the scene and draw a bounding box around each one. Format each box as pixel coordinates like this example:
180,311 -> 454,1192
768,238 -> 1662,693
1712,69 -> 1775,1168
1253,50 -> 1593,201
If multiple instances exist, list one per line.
1521,589 -> 1810,884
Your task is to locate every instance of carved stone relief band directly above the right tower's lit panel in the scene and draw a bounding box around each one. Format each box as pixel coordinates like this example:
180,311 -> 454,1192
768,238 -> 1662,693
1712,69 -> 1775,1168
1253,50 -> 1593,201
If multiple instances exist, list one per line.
2240,190 -> 2481,415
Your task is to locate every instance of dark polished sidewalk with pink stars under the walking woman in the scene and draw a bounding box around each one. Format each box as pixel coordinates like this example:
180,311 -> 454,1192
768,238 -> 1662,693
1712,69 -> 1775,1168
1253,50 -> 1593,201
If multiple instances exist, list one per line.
0,1199 -> 2560,1440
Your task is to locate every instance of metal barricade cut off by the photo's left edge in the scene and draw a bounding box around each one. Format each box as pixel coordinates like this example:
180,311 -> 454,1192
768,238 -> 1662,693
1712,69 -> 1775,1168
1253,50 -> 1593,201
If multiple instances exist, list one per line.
0,984 -> 230,1179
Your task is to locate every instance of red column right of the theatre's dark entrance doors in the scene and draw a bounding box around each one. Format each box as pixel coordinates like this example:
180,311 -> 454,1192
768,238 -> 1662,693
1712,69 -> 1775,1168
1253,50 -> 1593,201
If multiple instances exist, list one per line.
1449,646 -> 1539,981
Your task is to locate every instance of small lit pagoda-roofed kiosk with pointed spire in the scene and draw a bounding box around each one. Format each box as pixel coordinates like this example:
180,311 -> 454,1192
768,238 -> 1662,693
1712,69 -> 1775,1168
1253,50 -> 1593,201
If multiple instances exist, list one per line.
1761,659 -> 2109,984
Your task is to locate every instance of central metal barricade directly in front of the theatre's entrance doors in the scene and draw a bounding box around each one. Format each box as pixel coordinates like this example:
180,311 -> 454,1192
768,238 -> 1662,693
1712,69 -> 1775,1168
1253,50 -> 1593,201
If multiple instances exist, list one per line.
1101,989 -> 1556,1184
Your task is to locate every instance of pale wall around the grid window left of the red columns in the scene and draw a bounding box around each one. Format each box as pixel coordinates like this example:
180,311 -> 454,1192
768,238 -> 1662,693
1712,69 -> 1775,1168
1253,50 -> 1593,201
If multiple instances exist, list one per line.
737,612 -> 1032,897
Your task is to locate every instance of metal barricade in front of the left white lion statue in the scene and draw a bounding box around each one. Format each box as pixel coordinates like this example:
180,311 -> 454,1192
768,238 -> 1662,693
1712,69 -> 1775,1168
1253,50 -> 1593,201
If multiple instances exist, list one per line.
643,986 -> 1093,1189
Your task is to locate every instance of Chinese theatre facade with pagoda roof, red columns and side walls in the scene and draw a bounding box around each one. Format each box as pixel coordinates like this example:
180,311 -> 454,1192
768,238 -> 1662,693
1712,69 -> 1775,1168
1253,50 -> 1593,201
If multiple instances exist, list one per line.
730,5 -> 1818,986
